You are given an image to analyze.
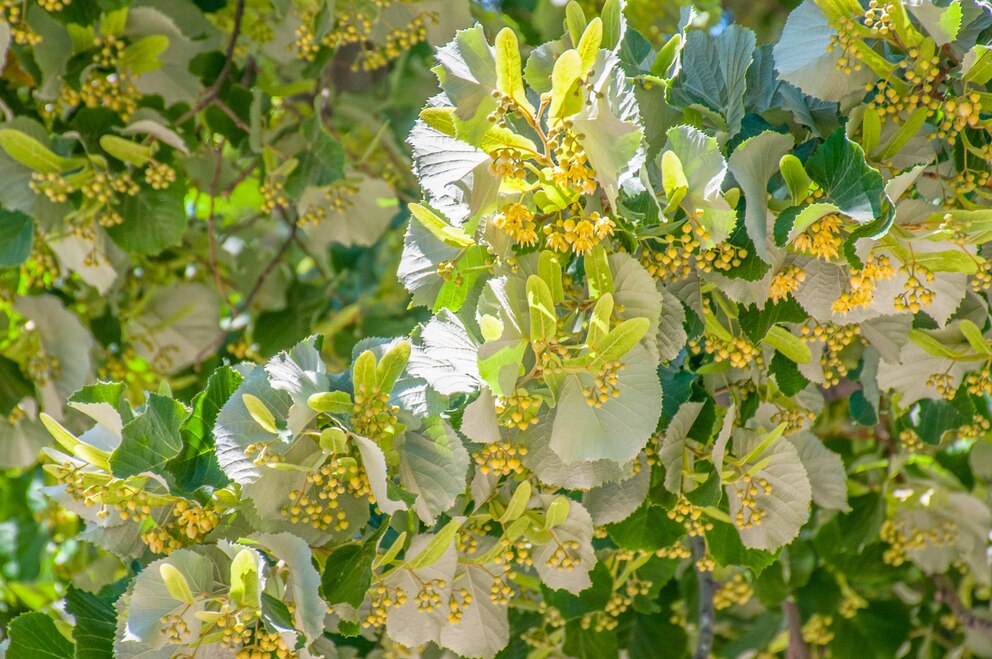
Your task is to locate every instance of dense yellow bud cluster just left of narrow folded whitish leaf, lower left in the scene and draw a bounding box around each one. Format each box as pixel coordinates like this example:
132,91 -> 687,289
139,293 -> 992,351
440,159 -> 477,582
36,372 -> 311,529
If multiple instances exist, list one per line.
279,455 -> 375,531
